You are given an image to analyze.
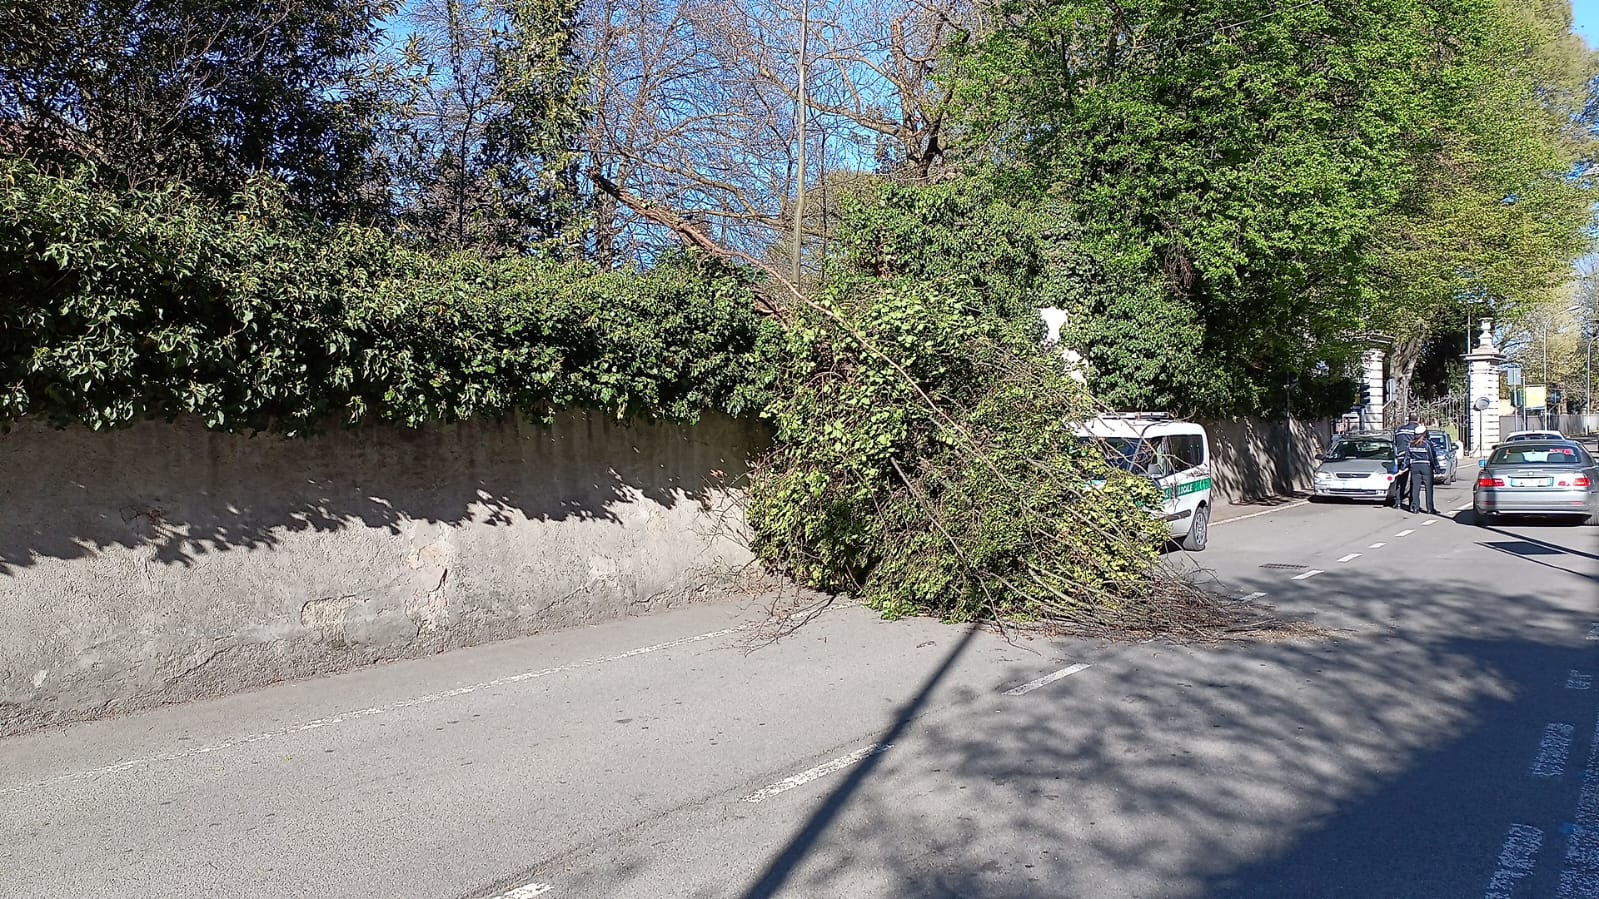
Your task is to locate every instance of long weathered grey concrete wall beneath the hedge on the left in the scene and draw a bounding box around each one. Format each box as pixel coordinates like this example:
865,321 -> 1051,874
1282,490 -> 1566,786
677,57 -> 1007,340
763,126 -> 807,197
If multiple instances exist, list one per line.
0,414 -> 763,734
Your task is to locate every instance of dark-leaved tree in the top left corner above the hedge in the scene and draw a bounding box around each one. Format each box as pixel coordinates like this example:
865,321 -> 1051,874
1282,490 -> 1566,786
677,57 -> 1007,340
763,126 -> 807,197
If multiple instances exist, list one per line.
0,0 -> 389,218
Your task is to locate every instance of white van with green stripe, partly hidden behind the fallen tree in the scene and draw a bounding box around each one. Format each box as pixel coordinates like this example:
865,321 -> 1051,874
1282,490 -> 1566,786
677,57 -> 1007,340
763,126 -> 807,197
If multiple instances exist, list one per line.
1078,413 -> 1212,552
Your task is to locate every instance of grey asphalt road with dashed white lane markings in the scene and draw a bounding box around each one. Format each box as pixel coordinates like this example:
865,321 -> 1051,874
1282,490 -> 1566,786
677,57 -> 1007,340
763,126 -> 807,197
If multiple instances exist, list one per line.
0,473 -> 1599,899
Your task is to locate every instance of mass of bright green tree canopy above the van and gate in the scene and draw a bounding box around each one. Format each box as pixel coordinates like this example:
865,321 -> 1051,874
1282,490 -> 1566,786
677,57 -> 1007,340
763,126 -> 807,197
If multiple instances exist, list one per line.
948,0 -> 1593,414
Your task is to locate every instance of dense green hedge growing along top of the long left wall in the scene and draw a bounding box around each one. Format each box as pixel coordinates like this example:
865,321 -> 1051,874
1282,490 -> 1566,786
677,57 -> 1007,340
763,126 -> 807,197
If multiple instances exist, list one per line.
0,162 -> 763,432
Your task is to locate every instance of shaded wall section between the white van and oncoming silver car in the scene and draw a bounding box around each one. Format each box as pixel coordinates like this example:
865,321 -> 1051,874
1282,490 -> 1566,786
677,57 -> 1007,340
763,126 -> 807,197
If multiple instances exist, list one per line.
1204,419 -> 1332,502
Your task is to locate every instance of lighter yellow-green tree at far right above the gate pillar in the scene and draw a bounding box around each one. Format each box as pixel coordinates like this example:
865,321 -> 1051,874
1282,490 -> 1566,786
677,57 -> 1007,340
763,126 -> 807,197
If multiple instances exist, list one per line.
1367,0 -> 1599,402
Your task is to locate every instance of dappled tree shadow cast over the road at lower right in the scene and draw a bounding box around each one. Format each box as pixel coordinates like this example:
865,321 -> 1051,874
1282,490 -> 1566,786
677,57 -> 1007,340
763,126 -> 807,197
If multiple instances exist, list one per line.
712,559 -> 1599,899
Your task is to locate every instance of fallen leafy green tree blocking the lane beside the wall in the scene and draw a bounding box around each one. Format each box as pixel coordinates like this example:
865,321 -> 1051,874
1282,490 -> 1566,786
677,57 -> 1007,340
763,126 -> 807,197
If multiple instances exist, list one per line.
748,186 -> 1166,624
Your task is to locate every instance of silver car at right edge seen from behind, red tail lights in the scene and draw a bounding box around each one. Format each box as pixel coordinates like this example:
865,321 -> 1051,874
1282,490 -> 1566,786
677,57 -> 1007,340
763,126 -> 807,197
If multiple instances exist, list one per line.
1471,440 -> 1599,525
